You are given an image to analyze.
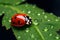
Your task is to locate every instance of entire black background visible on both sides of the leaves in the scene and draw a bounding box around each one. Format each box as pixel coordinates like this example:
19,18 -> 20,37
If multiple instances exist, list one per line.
0,0 -> 60,40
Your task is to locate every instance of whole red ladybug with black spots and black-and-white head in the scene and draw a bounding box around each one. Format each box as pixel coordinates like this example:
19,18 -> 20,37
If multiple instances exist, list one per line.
11,13 -> 32,27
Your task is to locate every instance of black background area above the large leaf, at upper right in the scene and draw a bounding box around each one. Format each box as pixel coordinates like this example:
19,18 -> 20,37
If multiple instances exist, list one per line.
21,0 -> 60,16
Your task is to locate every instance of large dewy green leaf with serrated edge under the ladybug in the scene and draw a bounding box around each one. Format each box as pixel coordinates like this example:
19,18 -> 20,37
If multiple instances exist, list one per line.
0,4 -> 60,40
